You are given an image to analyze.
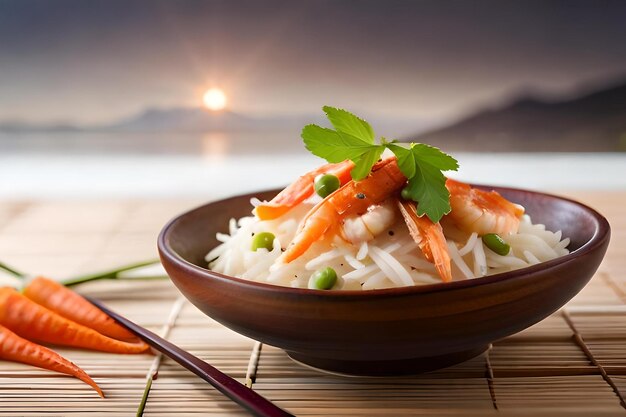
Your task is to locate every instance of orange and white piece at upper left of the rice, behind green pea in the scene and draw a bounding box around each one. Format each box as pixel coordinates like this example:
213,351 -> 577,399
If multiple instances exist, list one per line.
256,161 -> 354,220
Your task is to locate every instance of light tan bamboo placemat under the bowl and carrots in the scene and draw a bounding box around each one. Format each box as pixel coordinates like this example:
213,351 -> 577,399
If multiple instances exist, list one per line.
0,192 -> 626,416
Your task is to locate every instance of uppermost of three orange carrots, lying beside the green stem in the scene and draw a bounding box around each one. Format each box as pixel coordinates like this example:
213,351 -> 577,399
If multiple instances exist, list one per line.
23,277 -> 138,341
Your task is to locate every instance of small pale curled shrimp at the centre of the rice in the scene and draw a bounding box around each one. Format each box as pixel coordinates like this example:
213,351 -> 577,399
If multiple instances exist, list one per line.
341,199 -> 396,245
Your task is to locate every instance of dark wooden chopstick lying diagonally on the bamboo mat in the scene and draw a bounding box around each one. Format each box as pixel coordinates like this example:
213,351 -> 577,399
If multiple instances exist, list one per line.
89,298 -> 293,417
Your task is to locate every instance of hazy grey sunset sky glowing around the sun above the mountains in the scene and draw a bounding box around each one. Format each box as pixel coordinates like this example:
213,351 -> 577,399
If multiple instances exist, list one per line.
0,0 -> 626,124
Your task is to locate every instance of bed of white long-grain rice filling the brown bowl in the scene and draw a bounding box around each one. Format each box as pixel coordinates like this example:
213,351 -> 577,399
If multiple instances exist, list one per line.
206,198 -> 570,290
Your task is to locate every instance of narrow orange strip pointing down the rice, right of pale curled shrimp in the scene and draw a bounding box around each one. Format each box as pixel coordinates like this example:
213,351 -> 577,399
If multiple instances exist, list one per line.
397,200 -> 452,282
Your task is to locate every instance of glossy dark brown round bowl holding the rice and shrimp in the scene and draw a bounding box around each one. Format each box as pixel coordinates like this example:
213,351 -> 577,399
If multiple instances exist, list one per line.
158,187 -> 610,375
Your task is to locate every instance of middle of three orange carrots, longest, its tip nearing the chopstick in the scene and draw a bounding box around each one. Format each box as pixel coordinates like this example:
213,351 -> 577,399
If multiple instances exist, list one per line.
0,288 -> 149,353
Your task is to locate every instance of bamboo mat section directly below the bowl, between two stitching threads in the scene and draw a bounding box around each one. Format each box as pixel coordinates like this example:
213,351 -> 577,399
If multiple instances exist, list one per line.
253,346 -> 493,415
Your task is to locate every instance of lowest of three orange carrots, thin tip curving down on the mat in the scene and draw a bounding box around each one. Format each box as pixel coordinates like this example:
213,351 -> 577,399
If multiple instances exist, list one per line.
0,325 -> 104,398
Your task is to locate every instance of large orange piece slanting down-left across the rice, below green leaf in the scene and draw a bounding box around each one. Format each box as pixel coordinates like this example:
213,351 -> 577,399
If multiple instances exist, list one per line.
278,158 -> 406,263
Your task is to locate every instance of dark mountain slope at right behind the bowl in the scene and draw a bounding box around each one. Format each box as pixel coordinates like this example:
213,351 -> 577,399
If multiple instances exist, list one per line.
410,79 -> 626,152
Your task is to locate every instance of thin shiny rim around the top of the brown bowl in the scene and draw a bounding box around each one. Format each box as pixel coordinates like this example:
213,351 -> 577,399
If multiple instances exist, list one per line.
157,183 -> 611,300
